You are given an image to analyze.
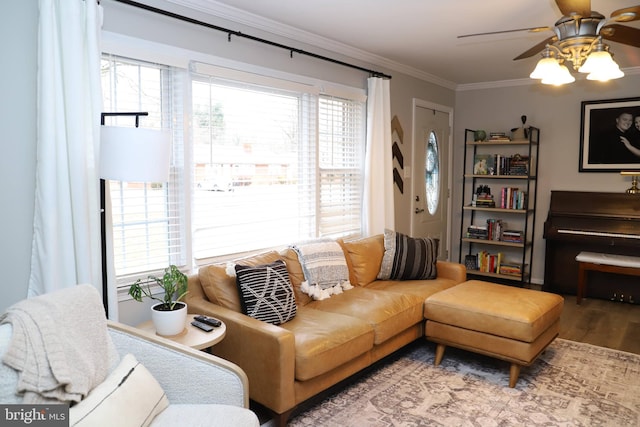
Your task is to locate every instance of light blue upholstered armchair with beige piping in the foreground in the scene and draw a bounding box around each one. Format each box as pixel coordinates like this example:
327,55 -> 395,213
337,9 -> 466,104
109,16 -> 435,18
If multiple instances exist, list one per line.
0,298 -> 260,427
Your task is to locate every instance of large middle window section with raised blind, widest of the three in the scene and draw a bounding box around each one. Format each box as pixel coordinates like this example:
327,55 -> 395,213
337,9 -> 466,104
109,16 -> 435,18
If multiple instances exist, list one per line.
192,76 -> 316,258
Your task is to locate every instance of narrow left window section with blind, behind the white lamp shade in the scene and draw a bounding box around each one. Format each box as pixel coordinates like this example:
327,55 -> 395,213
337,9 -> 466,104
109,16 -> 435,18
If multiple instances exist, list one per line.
102,56 -> 186,281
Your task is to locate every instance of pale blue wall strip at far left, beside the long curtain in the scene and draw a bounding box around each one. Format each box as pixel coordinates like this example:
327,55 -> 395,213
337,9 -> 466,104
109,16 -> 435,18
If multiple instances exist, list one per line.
0,0 -> 38,313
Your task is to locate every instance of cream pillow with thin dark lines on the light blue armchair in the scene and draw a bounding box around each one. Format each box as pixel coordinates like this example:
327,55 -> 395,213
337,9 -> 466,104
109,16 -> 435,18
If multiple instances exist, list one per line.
69,354 -> 169,427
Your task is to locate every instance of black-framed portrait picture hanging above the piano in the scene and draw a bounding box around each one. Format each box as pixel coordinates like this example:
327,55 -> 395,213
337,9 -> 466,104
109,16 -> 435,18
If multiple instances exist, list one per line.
580,98 -> 640,172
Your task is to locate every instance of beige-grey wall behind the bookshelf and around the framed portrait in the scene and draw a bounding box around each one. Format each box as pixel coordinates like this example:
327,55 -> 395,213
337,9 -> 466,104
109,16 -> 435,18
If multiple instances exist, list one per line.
452,77 -> 640,283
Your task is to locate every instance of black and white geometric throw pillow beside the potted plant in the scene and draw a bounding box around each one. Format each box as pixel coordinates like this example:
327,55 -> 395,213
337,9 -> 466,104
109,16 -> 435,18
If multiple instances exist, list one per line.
235,260 -> 297,325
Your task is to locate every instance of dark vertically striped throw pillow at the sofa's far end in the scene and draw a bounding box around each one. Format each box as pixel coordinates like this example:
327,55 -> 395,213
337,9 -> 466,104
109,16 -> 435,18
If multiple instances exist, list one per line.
378,230 -> 439,280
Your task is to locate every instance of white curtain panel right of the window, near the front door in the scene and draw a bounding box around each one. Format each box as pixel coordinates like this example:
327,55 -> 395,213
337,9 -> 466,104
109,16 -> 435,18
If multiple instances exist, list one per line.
362,77 -> 395,236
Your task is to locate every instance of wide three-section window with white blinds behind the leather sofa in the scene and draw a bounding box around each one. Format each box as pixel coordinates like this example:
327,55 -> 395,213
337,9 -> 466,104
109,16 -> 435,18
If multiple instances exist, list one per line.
102,56 -> 365,283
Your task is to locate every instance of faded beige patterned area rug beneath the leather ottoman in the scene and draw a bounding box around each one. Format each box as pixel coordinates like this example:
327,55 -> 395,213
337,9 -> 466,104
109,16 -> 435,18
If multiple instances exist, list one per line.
289,339 -> 640,427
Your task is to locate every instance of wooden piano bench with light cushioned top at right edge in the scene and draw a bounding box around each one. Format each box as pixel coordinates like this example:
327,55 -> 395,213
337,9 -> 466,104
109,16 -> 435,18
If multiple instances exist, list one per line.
576,252 -> 640,304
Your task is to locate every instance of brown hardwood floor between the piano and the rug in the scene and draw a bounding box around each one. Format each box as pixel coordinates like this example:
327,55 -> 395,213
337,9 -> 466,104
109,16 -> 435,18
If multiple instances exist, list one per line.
560,295 -> 640,354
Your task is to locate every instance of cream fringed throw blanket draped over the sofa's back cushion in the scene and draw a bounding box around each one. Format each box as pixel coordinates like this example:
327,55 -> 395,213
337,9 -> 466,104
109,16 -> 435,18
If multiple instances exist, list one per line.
291,240 -> 353,300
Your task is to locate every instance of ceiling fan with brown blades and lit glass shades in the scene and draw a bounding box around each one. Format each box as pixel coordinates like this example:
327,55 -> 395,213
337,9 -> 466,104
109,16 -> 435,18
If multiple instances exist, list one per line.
458,0 -> 640,84
